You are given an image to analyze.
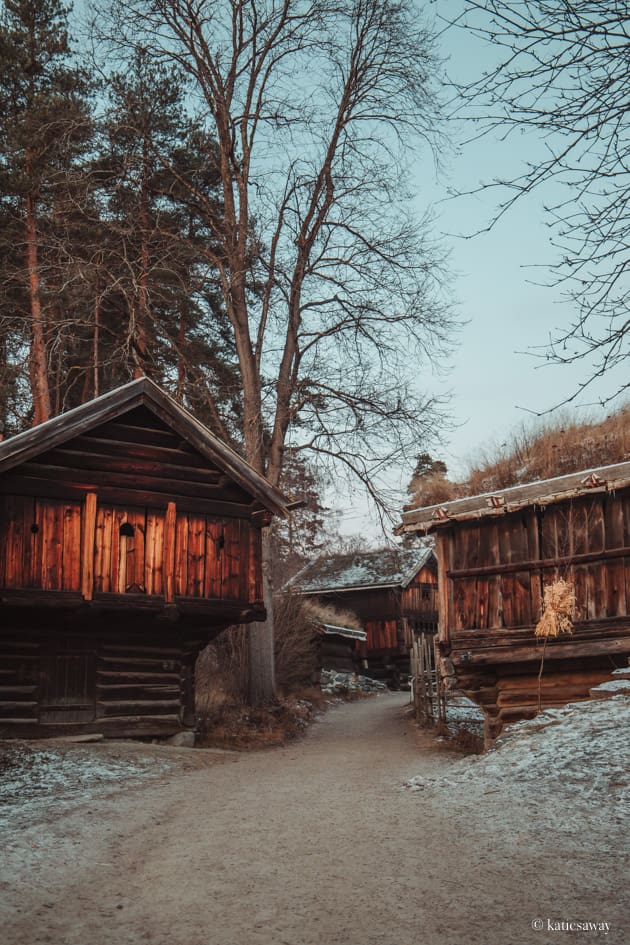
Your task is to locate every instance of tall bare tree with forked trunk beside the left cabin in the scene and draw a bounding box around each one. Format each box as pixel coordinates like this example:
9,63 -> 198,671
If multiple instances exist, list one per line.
96,0 -> 452,702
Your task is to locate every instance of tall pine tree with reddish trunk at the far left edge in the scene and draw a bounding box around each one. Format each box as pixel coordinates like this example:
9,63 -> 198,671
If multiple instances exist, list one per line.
0,0 -> 92,423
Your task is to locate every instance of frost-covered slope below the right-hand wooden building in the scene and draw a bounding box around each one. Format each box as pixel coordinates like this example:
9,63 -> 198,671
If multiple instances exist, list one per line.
405,695 -> 630,831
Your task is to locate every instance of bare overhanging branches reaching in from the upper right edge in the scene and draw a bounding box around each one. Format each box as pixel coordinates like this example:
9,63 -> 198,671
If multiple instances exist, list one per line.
451,0 -> 630,401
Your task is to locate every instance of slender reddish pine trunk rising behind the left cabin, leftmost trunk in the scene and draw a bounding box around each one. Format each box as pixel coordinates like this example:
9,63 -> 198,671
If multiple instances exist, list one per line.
26,182 -> 52,425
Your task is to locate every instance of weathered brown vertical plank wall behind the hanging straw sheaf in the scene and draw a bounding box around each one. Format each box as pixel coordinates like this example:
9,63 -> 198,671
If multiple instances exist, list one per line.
446,493 -> 630,639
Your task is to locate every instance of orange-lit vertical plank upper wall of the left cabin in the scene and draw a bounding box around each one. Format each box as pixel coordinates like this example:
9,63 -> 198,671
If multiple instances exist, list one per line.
0,493 -> 262,601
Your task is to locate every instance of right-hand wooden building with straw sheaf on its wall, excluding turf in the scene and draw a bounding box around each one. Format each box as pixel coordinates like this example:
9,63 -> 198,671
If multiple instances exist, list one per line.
398,462 -> 630,742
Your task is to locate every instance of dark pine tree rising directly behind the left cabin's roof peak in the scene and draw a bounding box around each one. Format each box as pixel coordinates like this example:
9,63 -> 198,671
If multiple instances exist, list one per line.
94,52 -> 241,439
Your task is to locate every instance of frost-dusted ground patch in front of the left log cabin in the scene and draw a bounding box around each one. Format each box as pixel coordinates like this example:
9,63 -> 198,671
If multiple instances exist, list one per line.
0,742 -> 177,827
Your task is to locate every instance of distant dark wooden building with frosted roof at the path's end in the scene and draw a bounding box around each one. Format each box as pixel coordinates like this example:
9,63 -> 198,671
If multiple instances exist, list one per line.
289,547 -> 437,686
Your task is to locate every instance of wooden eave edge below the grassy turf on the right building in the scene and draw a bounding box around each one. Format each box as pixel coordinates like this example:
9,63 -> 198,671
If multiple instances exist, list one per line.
396,462 -> 630,534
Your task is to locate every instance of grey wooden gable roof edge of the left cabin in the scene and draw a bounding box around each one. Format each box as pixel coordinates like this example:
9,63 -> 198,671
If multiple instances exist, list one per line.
0,377 -> 288,516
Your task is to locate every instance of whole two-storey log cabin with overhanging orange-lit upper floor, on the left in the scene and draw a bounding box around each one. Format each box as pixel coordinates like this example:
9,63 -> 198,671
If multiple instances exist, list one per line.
0,378 -> 287,737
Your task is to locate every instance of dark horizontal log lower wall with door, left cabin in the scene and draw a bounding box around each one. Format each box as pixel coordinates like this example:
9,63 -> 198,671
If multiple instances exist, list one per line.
0,628 -> 205,737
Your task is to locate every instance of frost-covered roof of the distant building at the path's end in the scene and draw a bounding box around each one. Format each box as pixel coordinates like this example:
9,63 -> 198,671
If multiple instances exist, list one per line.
287,546 -> 434,594
